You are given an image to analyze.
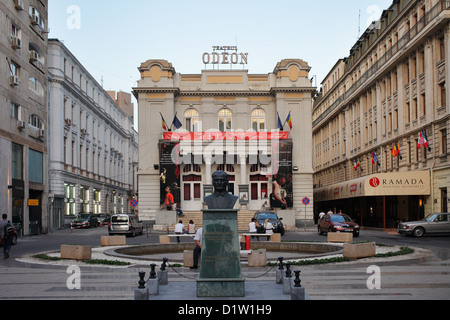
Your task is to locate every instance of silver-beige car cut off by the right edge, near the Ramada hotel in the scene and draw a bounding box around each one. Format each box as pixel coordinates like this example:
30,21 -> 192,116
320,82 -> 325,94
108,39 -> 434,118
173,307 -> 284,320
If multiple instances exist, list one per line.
397,213 -> 450,238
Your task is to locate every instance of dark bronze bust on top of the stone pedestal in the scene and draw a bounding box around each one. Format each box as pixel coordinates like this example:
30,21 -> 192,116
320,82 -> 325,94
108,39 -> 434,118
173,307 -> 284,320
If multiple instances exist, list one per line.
205,171 -> 238,209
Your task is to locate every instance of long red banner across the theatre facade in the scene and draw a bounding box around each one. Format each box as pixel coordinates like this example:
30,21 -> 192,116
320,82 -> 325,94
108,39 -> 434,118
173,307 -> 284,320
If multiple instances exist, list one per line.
164,131 -> 289,141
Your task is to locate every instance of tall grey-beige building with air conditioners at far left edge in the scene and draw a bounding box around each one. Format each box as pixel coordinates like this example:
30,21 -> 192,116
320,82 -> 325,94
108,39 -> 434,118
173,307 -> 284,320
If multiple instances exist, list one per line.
0,0 -> 48,235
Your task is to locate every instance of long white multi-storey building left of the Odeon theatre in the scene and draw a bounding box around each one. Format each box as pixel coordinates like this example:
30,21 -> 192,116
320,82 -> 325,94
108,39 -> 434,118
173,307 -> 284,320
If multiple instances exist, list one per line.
48,39 -> 138,228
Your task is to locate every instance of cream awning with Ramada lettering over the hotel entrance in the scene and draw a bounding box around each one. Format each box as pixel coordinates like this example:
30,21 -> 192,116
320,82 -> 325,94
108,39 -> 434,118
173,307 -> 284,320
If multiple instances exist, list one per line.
314,171 -> 431,202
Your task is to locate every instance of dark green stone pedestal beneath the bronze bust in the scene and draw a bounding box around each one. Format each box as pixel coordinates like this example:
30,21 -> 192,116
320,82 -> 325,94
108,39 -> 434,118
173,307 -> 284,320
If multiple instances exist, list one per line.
197,210 -> 245,297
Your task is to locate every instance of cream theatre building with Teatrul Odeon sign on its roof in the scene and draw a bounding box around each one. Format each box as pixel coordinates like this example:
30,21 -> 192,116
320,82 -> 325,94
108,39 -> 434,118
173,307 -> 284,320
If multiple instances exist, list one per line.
133,55 -> 316,221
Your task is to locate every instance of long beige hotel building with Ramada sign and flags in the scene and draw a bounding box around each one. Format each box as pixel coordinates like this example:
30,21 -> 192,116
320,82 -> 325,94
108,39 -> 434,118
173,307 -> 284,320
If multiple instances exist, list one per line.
312,0 -> 450,228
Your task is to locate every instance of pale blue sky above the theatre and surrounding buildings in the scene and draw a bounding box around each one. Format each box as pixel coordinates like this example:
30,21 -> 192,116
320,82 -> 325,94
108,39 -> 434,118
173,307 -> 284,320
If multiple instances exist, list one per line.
49,0 -> 392,129
